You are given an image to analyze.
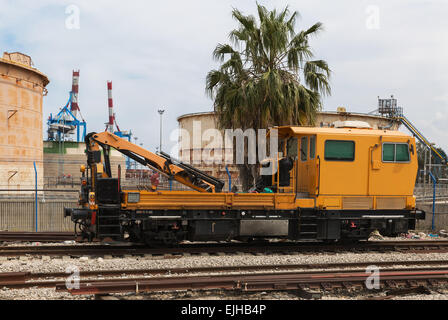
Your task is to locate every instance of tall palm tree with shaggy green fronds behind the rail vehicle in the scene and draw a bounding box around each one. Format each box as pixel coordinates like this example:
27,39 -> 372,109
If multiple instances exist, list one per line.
206,4 -> 331,190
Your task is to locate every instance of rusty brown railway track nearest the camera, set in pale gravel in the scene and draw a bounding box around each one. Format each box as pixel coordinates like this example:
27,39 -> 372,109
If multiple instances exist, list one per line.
0,260 -> 448,295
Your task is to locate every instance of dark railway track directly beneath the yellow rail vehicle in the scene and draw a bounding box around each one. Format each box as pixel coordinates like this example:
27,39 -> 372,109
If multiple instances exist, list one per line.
0,240 -> 448,257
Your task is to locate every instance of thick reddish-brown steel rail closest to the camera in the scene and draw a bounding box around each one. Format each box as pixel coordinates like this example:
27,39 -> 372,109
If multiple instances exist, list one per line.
56,268 -> 448,295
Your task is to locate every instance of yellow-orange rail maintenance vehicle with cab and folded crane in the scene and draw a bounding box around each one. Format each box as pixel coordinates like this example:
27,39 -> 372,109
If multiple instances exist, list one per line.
65,126 -> 424,243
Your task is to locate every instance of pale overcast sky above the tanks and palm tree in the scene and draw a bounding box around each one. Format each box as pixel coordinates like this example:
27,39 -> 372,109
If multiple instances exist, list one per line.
0,0 -> 448,151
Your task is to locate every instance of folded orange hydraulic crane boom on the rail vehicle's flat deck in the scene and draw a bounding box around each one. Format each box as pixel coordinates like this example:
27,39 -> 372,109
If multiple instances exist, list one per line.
86,131 -> 224,192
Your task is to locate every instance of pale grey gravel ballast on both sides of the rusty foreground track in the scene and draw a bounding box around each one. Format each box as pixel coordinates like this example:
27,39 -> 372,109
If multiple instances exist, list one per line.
0,252 -> 448,300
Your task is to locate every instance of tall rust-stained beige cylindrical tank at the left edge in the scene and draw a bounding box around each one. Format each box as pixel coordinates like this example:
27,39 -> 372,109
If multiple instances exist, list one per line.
0,52 -> 49,194
